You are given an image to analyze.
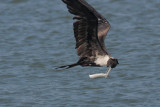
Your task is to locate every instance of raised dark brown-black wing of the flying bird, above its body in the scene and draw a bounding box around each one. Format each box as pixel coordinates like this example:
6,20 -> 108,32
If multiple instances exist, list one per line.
62,0 -> 110,57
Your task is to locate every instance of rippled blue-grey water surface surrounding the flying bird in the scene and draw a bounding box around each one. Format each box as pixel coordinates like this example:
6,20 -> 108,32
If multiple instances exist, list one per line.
0,0 -> 160,107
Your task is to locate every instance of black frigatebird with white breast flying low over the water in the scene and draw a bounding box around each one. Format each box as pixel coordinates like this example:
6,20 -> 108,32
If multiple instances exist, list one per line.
58,0 -> 119,76
